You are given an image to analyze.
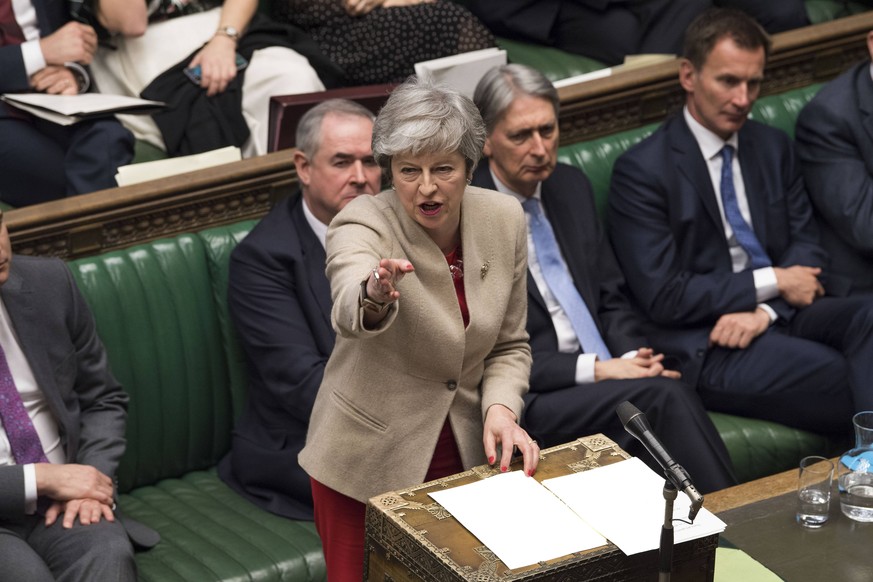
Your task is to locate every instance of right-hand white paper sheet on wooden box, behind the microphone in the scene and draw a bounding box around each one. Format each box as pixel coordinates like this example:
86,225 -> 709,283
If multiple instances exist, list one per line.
544,458 -> 725,555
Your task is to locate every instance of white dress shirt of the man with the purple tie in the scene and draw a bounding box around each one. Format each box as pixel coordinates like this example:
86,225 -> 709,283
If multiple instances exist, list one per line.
0,301 -> 66,513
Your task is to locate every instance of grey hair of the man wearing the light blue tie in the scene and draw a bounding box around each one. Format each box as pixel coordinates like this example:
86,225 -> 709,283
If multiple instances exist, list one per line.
473,64 -> 561,135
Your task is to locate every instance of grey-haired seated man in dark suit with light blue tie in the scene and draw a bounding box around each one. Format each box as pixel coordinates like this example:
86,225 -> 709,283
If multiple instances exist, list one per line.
473,65 -> 734,491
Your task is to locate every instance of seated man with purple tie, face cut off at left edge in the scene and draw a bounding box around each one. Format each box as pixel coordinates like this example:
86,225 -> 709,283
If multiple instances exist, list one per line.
0,213 -> 136,582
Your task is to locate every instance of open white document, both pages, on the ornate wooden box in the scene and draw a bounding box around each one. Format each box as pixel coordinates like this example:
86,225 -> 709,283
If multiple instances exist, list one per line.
430,459 -> 725,569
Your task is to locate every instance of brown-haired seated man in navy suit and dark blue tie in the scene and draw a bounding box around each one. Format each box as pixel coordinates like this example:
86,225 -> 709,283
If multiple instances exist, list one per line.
609,9 -> 873,432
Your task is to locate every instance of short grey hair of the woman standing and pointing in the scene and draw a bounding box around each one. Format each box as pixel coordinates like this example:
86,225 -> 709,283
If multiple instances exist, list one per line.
373,77 -> 485,176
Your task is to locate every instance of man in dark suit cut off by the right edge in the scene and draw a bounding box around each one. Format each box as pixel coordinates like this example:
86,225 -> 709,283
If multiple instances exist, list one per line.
796,32 -> 873,293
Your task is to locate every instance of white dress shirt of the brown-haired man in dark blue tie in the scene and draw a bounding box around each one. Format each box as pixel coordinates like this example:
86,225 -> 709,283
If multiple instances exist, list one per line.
683,106 -> 779,323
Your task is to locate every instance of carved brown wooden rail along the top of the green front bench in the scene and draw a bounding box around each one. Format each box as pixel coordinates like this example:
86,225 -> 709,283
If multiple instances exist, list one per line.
5,12 -> 873,259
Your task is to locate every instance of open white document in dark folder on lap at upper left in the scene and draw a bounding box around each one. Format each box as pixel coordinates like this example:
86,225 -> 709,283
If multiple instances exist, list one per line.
0,93 -> 165,125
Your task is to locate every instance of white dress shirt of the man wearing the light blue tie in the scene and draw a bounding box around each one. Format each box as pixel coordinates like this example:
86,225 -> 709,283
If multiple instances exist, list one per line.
491,172 -> 637,384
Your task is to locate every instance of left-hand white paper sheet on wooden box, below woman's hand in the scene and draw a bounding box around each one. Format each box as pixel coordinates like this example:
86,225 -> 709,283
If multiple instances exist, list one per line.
430,471 -> 606,569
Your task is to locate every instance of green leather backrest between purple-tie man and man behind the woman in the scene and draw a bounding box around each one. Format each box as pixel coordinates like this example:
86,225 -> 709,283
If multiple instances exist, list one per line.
69,222 -> 252,492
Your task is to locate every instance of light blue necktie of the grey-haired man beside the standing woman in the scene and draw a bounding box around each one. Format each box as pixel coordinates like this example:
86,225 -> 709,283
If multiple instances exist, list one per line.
523,198 -> 612,361
